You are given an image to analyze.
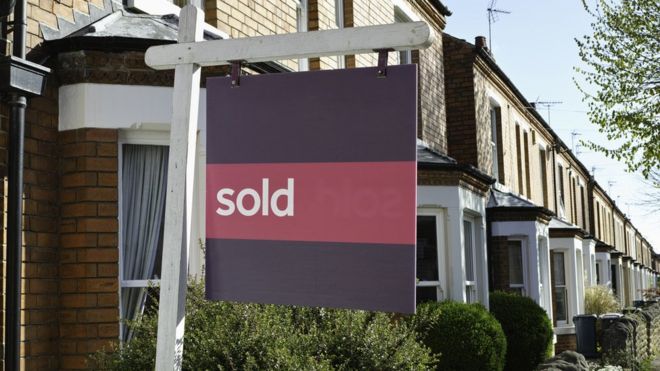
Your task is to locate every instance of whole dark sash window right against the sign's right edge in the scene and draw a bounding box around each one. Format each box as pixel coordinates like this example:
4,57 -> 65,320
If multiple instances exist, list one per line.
417,212 -> 440,303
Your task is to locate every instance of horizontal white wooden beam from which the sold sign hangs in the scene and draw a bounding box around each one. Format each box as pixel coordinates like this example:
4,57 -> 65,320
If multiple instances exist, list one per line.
144,22 -> 435,70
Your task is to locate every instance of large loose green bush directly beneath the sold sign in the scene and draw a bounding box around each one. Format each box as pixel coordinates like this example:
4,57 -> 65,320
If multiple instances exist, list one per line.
92,283 -> 435,370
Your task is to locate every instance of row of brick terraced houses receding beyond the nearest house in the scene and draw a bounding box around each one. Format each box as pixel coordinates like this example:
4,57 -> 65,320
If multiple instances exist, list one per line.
443,34 -> 658,352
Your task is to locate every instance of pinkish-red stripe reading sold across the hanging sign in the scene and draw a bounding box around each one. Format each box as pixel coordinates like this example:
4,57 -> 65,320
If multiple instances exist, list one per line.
206,161 -> 417,244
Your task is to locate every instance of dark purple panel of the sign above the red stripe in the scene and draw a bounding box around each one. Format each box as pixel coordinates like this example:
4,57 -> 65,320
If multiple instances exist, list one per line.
207,65 -> 417,163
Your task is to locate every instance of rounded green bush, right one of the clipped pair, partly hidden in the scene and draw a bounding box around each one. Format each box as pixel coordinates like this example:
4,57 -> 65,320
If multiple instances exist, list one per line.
490,292 -> 553,370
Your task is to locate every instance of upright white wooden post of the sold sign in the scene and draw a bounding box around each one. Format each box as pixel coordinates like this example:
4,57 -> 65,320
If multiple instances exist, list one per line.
156,5 -> 204,371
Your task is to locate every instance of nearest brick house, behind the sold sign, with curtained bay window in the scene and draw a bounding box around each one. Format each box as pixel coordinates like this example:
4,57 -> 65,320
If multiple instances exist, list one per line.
0,0 -> 492,369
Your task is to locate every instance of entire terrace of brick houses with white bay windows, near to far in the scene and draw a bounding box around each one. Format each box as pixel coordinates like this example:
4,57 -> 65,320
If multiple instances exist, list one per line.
0,0 -> 660,370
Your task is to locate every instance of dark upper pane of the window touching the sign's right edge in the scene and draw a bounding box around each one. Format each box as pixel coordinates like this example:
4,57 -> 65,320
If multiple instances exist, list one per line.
417,215 -> 438,281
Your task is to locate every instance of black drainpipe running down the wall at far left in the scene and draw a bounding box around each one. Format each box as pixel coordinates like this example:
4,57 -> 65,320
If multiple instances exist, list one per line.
5,0 -> 27,371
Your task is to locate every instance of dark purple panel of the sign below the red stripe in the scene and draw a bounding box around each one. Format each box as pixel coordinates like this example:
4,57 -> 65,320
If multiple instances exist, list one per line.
206,239 -> 415,313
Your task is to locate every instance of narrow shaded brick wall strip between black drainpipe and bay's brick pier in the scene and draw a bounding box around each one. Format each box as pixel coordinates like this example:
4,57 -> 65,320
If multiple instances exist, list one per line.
18,80 -> 59,370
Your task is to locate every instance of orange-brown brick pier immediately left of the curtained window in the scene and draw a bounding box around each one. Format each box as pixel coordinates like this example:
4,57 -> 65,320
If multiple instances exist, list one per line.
59,129 -> 119,369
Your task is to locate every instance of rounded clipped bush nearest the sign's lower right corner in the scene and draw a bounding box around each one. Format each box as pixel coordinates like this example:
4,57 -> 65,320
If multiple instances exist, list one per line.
411,302 -> 507,371
